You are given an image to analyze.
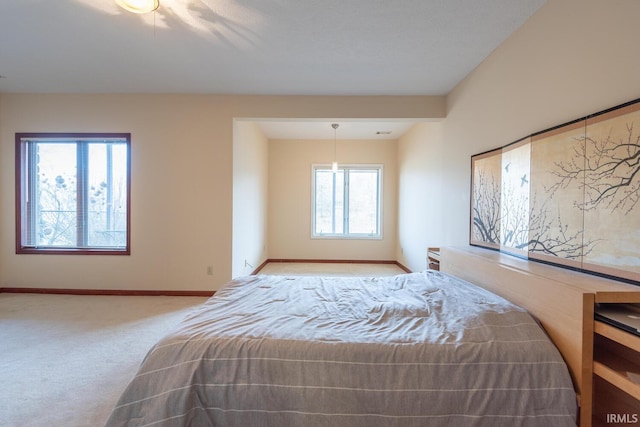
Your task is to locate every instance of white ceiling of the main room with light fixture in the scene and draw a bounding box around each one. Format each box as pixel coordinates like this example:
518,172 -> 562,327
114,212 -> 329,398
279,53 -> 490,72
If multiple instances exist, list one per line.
0,0 -> 545,139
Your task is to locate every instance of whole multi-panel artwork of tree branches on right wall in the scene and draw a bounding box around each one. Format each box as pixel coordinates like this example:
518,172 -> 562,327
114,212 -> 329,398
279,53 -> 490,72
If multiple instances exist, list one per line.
470,96 -> 640,284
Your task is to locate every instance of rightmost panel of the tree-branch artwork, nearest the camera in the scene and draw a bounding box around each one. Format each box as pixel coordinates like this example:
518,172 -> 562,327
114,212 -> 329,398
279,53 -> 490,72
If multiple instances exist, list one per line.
584,104 -> 640,281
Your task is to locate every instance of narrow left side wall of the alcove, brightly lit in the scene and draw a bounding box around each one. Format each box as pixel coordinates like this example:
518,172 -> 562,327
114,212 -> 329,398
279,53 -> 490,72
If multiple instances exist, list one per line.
231,120 -> 269,277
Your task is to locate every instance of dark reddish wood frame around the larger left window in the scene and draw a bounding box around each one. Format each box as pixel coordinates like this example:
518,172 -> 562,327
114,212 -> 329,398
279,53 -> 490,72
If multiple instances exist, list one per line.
15,132 -> 131,255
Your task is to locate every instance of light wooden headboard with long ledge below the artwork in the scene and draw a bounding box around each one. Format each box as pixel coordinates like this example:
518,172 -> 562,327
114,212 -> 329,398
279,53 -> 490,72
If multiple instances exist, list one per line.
440,246 -> 640,427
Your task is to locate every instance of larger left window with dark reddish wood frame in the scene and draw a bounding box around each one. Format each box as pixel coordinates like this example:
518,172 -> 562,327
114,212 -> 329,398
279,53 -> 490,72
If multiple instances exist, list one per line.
16,133 -> 131,255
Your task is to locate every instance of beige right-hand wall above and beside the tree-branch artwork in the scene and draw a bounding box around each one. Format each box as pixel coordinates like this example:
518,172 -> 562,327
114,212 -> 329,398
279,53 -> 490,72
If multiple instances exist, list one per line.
400,0 -> 640,260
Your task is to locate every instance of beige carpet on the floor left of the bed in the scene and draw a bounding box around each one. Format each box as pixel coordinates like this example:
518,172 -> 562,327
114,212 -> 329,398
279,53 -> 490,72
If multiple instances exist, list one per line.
0,294 -> 206,427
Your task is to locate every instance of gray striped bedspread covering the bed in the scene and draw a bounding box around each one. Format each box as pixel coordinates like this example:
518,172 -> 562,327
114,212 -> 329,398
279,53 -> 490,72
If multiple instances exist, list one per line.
107,270 -> 577,427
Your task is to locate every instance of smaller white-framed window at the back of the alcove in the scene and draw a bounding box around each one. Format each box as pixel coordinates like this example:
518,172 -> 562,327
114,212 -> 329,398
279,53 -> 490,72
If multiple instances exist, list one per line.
312,165 -> 382,239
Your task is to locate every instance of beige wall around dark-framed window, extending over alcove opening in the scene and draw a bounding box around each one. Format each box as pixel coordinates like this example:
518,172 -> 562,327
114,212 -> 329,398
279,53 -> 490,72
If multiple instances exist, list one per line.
0,94 -> 444,290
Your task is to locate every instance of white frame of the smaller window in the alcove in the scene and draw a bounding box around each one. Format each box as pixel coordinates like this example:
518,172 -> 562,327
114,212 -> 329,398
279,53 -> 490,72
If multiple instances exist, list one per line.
311,163 -> 384,240
